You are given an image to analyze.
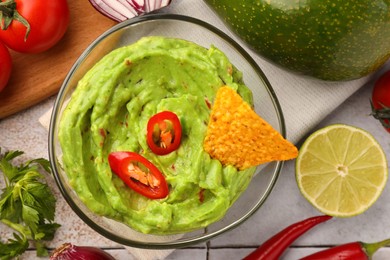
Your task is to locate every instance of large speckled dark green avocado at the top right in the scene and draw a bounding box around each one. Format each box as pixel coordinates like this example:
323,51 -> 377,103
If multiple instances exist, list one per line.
205,0 -> 390,81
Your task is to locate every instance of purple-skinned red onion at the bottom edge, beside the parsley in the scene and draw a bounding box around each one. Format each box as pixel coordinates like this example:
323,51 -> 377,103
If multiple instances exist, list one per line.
50,243 -> 115,260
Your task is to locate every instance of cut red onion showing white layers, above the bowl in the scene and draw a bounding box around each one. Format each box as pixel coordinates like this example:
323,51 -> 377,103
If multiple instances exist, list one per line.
89,0 -> 171,22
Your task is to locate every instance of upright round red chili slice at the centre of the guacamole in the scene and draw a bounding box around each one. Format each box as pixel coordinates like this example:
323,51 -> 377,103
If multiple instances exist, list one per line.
146,111 -> 182,155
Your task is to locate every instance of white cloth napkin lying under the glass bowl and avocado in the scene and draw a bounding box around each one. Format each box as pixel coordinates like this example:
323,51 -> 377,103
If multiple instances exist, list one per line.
40,0 -> 386,259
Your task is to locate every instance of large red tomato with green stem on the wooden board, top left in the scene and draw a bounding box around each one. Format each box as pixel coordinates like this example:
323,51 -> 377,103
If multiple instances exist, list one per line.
0,0 -> 69,53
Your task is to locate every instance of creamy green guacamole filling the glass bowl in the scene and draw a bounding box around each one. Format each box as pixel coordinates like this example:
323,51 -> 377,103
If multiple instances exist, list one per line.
59,36 -> 255,234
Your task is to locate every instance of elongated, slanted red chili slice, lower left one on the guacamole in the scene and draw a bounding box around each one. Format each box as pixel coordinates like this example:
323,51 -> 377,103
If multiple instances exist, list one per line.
108,152 -> 169,199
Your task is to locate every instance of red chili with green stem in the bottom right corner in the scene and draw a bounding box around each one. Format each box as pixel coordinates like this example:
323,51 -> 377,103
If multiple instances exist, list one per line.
301,239 -> 390,260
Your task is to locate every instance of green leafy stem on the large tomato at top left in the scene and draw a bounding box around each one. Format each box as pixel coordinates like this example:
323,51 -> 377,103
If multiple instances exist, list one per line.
0,0 -> 31,41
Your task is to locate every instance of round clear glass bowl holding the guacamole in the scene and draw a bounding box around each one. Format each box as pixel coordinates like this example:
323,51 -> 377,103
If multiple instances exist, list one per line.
49,14 -> 286,249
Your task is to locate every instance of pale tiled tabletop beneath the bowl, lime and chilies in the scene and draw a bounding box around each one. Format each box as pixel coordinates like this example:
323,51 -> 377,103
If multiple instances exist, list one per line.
0,68 -> 390,260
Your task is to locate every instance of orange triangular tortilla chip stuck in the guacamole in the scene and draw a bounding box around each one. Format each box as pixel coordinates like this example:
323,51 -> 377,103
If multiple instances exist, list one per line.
203,86 -> 298,170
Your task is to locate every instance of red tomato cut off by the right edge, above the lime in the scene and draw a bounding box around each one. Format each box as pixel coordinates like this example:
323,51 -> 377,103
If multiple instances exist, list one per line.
371,70 -> 390,133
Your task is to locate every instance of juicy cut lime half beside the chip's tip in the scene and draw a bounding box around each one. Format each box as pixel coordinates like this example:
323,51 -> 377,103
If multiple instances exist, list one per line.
296,124 -> 388,217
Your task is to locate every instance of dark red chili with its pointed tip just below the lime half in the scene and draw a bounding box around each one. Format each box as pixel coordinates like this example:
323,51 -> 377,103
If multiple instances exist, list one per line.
244,215 -> 332,260
